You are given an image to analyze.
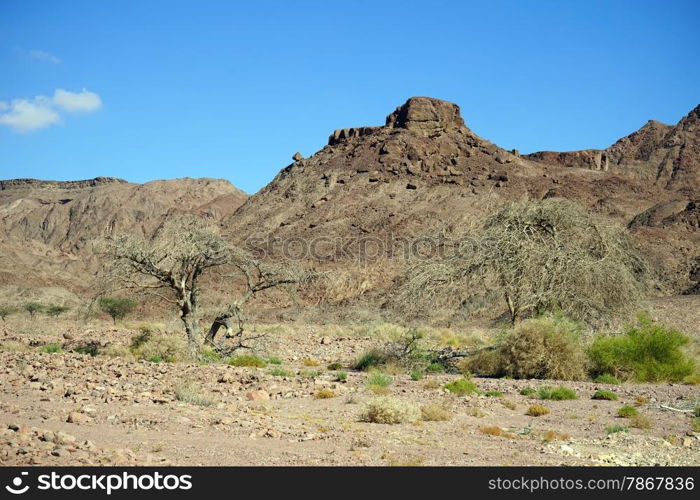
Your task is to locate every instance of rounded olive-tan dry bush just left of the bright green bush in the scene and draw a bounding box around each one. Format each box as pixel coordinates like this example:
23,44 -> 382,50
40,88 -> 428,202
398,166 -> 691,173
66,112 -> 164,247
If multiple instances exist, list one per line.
499,315 -> 588,380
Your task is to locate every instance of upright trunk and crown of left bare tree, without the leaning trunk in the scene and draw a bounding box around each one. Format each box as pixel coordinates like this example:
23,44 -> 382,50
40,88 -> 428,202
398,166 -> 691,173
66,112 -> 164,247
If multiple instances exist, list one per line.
108,215 -> 231,359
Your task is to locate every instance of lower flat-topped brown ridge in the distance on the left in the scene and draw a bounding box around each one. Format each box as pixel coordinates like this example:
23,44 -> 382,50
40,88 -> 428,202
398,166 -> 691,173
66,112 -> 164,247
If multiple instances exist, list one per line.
0,177 -> 247,292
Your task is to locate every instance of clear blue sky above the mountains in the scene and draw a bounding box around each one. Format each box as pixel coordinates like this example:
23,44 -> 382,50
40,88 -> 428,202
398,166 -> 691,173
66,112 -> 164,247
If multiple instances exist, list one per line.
0,0 -> 700,193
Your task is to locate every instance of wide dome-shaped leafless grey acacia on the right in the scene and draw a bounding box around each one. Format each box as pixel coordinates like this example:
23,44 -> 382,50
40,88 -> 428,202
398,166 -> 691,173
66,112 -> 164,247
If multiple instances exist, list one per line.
401,199 -> 648,323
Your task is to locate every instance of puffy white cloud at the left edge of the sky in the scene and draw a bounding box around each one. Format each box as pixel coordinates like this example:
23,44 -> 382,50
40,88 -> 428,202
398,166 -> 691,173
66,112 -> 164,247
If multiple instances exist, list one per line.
0,89 -> 102,132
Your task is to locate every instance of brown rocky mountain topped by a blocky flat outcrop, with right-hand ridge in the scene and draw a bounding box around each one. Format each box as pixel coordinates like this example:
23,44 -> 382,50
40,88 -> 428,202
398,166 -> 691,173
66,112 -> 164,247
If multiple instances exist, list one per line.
224,97 -> 700,299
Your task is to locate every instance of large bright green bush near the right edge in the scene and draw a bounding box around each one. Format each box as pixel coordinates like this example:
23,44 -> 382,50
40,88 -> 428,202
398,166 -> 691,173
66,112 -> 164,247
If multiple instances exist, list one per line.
589,315 -> 695,382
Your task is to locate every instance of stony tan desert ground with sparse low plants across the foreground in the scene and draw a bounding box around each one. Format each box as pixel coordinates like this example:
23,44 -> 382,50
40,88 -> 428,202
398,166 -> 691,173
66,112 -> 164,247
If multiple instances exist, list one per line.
0,297 -> 700,466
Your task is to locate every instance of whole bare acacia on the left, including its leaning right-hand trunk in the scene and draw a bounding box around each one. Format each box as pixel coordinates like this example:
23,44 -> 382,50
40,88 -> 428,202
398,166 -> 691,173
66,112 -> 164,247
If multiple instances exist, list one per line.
108,216 -> 312,359
